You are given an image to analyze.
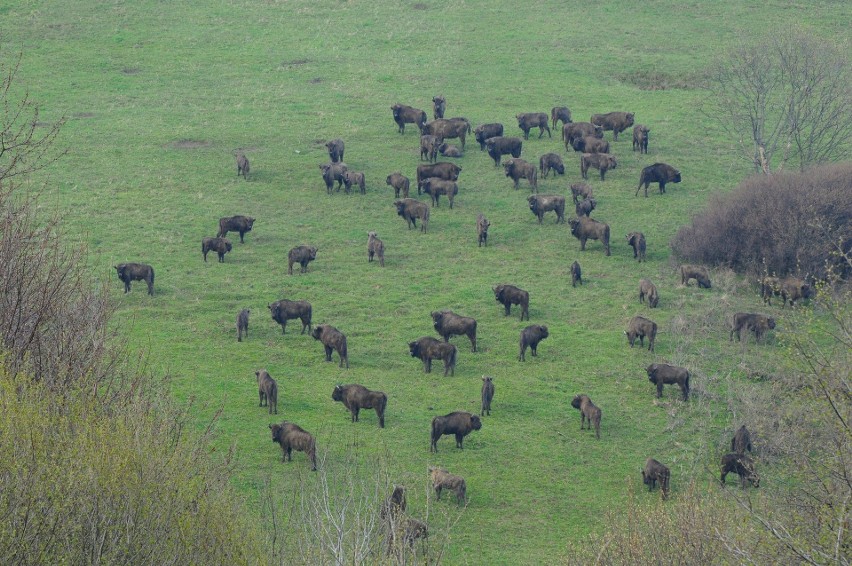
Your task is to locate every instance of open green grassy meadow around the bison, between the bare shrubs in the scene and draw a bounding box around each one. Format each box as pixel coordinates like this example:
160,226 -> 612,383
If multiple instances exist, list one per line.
0,0 -> 852,564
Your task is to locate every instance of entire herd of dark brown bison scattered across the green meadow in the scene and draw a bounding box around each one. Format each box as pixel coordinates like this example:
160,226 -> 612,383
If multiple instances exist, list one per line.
115,96 -> 813,544
